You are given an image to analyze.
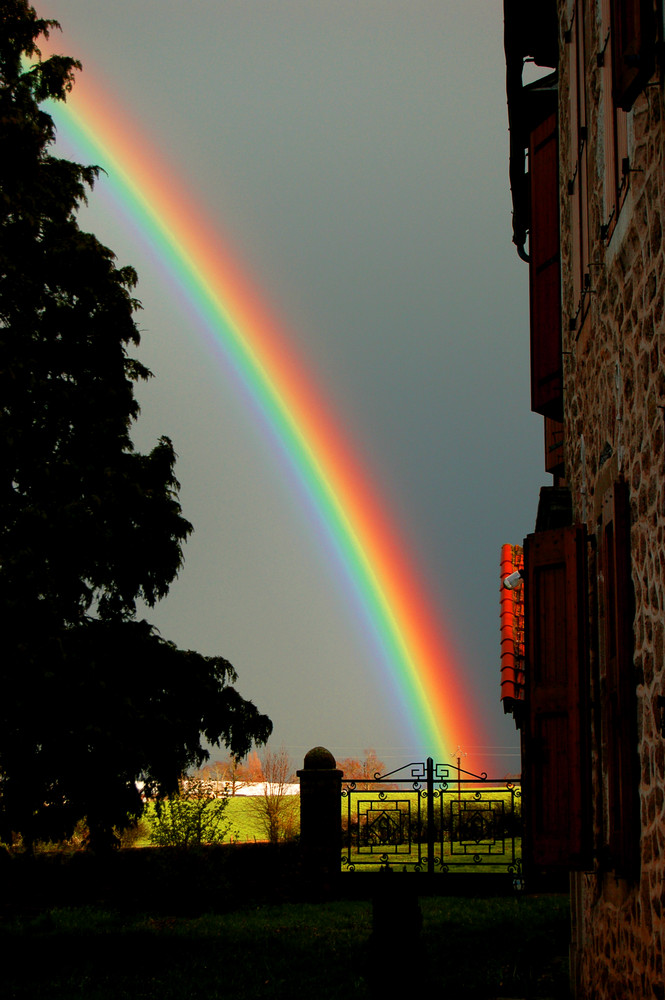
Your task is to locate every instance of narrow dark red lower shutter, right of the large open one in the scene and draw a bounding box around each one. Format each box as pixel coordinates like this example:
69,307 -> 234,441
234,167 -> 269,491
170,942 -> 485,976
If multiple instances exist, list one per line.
602,481 -> 639,875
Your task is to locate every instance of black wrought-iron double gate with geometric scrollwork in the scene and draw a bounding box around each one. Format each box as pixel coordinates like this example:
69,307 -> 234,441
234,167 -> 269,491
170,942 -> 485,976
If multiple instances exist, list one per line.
342,757 -> 522,879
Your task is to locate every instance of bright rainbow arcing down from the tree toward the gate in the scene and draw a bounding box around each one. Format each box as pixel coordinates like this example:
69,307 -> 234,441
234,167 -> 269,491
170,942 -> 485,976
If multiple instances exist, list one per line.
42,58 -> 484,762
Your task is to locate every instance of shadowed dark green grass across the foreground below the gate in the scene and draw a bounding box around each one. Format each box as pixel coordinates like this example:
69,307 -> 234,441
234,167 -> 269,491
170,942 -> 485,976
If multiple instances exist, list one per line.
0,892 -> 568,1000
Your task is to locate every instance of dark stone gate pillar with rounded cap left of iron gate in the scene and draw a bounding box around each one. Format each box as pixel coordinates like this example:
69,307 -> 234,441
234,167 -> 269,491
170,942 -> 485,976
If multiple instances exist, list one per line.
298,747 -> 342,886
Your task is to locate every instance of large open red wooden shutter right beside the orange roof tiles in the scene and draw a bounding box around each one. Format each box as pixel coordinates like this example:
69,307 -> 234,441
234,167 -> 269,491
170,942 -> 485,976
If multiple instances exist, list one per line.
524,526 -> 591,869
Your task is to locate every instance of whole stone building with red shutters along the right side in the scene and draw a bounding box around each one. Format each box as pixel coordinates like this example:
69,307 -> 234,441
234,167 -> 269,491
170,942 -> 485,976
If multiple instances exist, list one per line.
504,0 -> 665,1000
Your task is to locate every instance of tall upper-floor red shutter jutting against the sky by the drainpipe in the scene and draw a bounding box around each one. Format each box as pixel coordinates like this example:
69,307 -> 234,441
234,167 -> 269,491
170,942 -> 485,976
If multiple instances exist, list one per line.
529,115 -> 563,420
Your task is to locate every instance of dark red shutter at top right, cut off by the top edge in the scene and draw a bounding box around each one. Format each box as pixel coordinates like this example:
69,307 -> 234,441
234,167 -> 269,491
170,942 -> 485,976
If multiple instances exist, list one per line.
612,0 -> 654,111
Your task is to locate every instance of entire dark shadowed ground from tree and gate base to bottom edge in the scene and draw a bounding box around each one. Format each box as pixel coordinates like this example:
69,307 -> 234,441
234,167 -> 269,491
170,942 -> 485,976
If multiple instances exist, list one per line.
0,845 -> 568,1000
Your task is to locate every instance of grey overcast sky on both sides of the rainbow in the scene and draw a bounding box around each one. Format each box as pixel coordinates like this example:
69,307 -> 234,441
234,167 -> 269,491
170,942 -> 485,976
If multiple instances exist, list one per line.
36,0 -> 549,773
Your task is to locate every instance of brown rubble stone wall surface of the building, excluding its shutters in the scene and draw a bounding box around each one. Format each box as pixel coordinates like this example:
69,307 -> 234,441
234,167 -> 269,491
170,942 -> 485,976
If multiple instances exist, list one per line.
560,2 -> 665,1000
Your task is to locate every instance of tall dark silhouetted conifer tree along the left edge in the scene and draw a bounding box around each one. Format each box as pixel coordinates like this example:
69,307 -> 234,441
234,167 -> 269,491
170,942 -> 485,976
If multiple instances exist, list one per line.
0,0 -> 271,843
